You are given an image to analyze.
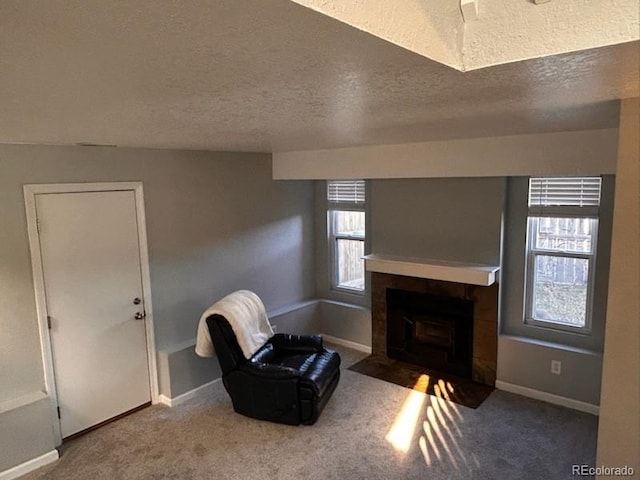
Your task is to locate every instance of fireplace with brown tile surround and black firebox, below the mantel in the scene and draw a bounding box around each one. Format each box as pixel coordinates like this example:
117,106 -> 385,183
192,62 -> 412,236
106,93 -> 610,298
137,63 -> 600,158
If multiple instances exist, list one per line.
371,271 -> 498,387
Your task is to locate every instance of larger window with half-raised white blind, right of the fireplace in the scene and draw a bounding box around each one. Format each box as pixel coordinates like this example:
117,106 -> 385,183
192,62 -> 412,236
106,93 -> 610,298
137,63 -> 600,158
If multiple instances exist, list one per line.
525,177 -> 601,333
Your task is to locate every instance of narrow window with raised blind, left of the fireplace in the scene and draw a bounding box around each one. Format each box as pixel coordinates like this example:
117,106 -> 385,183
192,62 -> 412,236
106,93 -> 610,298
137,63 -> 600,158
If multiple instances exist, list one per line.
327,180 -> 365,293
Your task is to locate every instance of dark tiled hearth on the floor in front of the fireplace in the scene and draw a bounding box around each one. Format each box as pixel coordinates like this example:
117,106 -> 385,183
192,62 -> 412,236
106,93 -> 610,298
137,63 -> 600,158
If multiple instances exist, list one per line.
348,355 -> 493,408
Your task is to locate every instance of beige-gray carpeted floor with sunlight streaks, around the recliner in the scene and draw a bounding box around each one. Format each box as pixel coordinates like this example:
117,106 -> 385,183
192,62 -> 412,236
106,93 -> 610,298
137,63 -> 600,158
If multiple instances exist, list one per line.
23,347 -> 597,480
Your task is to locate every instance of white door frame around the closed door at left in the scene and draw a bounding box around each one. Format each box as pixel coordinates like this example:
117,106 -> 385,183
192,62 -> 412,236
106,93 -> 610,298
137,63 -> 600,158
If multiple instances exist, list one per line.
23,182 -> 160,445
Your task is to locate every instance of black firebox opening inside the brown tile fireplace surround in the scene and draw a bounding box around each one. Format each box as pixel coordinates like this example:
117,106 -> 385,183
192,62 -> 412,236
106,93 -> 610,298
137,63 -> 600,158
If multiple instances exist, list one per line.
386,288 -> 473,379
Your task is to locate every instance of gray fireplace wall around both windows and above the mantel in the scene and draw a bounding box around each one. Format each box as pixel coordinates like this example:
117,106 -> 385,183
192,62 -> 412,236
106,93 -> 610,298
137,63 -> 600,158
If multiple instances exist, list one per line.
316,172 -> 613,405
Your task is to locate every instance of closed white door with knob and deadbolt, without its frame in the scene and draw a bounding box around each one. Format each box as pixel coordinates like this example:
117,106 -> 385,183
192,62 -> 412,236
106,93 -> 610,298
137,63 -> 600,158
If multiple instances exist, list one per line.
35,190 -> 151,438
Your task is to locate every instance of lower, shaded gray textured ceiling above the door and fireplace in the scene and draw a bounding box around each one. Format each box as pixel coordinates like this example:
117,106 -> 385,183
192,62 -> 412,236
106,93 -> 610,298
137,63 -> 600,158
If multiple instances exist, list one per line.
0,0 -> 639,151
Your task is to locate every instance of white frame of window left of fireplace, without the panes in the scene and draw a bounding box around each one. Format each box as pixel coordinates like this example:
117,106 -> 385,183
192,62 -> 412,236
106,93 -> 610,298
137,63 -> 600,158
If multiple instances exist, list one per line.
327,180 -> 367,296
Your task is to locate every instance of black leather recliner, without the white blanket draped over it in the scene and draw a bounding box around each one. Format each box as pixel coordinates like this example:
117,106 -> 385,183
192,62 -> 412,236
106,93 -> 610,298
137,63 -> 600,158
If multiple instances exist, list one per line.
207,314 -> 340,425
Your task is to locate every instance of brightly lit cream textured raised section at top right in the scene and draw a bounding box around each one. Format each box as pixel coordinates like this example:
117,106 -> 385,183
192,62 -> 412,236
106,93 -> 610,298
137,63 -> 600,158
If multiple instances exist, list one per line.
291,0 -> 640,72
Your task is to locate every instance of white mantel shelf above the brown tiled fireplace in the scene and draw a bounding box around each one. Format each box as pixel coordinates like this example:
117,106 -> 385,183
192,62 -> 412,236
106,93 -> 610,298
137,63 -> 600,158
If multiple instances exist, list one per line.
364,254 -> 500,287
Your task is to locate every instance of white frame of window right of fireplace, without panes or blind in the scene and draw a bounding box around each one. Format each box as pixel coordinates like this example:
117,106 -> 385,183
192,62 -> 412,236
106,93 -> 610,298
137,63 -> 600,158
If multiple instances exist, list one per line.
524,215 -> 599,335
